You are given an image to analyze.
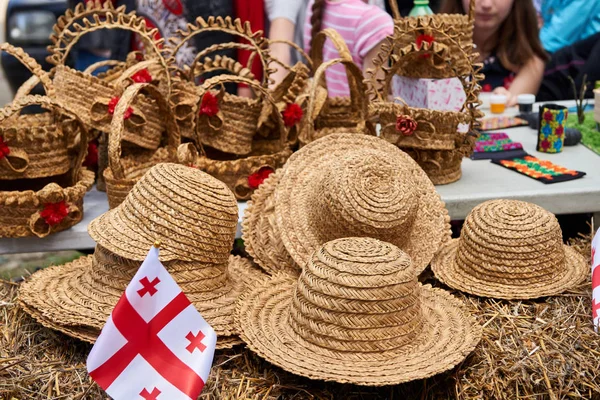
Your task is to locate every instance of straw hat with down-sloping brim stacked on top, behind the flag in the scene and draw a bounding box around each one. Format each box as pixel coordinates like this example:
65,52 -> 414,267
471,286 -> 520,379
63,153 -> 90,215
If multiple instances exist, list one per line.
90,163 -> 238,262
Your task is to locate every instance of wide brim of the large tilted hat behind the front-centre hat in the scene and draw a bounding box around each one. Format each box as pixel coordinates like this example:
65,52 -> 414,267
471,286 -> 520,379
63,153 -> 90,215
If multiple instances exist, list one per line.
273,134 -> 451,273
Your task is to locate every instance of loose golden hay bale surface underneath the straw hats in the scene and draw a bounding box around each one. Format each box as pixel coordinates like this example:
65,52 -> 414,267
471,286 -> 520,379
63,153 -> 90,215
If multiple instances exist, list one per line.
0,233 -> 600,400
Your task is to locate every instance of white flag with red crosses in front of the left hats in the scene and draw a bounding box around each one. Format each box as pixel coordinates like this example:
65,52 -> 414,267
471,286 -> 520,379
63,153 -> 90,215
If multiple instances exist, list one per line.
87,247 -> 217,400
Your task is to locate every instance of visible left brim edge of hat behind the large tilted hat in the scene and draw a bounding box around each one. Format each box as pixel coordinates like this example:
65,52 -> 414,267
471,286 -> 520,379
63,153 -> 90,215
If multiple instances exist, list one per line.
242,169 -> 301,275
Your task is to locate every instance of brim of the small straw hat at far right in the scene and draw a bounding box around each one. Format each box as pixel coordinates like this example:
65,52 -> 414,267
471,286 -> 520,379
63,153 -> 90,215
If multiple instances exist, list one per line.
431,239 -> 589,300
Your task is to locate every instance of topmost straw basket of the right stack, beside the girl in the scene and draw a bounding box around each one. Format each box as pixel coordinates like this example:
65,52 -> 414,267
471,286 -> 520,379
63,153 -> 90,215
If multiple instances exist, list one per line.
389,0 -> 476,79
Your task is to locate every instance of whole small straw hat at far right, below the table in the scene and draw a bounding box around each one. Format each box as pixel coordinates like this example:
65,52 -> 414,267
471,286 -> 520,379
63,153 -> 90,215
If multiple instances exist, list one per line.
431,200 -> 589,299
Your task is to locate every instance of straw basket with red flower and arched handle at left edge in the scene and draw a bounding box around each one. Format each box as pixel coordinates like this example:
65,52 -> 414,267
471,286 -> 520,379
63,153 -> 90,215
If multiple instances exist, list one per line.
0,96 -> 94,237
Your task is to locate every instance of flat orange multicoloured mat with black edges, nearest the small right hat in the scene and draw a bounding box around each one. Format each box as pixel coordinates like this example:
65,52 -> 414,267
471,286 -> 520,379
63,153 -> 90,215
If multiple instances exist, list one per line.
492,156 -> 585,183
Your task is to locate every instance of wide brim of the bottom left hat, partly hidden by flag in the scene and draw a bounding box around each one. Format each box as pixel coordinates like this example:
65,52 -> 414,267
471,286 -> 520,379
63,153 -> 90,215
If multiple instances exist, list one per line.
19,256 -> 266,348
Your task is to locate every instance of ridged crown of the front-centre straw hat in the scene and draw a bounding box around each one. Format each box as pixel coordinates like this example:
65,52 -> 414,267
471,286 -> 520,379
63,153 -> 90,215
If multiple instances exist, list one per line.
289,237 -> 423,352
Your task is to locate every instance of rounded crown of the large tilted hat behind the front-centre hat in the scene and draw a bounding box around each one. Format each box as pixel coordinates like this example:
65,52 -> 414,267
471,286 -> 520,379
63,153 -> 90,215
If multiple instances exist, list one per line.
310,149 -> 419,242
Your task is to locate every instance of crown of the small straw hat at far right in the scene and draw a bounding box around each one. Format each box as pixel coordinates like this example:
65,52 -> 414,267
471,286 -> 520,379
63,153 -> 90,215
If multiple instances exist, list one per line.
456,200 -> 565,286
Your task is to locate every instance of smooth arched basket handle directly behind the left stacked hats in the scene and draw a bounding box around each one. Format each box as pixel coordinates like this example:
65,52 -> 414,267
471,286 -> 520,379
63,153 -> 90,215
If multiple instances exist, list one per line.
108,83 -> 180,179
